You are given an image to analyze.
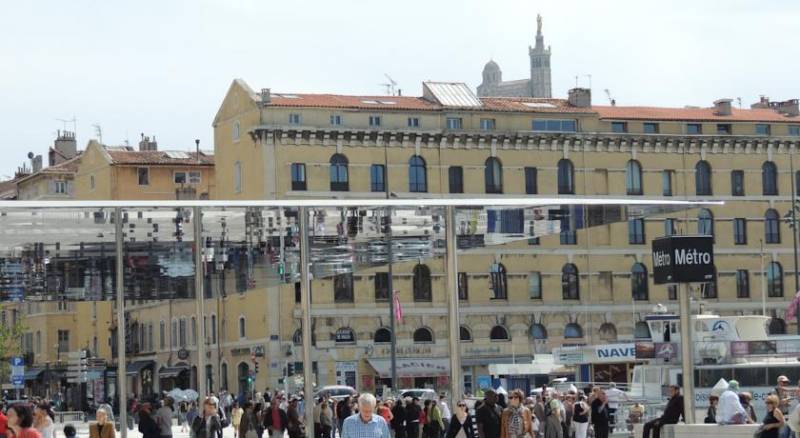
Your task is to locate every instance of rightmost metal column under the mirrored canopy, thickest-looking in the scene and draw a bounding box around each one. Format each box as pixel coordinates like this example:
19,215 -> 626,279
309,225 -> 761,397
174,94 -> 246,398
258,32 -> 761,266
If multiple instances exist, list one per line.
444,205 -> 464,409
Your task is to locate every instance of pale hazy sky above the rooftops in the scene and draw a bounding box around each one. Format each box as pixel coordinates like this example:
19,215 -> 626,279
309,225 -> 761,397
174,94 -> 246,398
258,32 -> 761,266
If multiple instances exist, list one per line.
0,0 -> 800,176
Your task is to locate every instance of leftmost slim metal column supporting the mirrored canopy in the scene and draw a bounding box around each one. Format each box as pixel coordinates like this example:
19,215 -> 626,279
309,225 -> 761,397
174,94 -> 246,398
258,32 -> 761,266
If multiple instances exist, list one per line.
114,207 -> 128,438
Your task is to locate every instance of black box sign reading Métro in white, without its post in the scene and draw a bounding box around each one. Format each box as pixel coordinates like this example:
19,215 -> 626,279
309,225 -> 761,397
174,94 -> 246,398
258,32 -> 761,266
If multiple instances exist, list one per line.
653,236 -> 716,284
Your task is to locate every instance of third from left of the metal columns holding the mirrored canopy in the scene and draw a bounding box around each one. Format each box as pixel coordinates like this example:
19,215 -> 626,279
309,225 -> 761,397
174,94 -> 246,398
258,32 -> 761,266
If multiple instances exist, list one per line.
299,207 -> 316,437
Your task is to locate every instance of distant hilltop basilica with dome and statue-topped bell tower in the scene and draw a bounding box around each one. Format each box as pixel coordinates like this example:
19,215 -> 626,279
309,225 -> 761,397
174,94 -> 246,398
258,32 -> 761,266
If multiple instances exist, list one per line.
478,15 -> 552,98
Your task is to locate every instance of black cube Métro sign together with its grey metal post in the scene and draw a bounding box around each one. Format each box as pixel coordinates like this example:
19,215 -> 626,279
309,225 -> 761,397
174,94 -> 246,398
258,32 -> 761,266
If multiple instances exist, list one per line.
653,236 -> 716,424
